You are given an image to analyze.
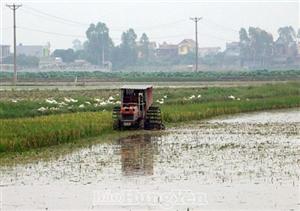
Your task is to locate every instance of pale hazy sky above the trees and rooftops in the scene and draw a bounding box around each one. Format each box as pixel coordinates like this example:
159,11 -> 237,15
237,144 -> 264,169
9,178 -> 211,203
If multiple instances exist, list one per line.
0,0 -> 299,50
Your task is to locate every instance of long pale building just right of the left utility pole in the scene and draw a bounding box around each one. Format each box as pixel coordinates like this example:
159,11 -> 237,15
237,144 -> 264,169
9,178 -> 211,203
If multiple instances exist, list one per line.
17,44 -> 50,58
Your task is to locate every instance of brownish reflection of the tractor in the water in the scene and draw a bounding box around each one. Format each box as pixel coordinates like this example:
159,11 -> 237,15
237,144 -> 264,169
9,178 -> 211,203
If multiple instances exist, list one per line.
119,135 -> 154,176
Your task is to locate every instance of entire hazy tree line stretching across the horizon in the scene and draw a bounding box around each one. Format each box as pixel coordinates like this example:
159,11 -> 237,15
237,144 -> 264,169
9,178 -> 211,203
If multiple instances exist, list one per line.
3,22 -> 300,69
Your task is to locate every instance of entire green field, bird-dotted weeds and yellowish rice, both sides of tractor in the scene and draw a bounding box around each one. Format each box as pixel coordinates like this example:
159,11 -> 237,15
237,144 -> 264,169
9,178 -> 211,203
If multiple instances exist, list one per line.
0,83 -> 300,152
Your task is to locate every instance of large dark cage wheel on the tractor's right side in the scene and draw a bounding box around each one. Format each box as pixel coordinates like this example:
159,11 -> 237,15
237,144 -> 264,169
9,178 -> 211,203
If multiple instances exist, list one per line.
145,106 -> 165,130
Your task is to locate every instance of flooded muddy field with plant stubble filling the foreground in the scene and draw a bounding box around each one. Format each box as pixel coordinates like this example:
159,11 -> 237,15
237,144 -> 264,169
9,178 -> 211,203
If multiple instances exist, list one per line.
0,109 -> 300,210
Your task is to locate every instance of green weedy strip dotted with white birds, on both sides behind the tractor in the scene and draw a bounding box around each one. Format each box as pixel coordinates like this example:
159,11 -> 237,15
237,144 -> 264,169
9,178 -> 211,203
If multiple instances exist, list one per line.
0,82 -> 300,118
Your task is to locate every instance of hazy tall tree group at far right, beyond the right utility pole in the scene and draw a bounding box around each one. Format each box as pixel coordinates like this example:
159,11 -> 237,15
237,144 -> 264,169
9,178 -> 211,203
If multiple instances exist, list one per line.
239,26 -> 300,66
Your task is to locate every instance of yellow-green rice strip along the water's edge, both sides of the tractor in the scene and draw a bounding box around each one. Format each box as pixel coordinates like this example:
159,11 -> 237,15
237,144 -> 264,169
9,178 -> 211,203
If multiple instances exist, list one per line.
0,95 -> 300,154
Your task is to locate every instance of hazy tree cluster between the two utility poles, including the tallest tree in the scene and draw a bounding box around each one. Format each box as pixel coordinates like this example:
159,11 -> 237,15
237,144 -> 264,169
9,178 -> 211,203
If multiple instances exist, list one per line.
53,22 -> 158,68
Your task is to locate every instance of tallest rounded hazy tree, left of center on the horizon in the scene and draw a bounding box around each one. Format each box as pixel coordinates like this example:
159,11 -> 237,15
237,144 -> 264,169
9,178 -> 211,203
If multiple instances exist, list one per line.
84,22 -> 113,65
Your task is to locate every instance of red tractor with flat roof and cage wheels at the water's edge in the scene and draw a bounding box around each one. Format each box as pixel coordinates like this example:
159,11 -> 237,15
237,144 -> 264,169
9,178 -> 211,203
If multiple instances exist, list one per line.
113,85 -> 164,129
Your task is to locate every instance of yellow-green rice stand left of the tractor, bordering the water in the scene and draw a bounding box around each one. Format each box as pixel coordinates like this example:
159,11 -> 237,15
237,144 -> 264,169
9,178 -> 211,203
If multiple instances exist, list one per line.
0,112 -> 112,152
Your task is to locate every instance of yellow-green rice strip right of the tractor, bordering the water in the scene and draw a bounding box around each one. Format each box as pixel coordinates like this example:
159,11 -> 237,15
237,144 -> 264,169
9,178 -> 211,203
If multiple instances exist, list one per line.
161,95 -> 300,123
